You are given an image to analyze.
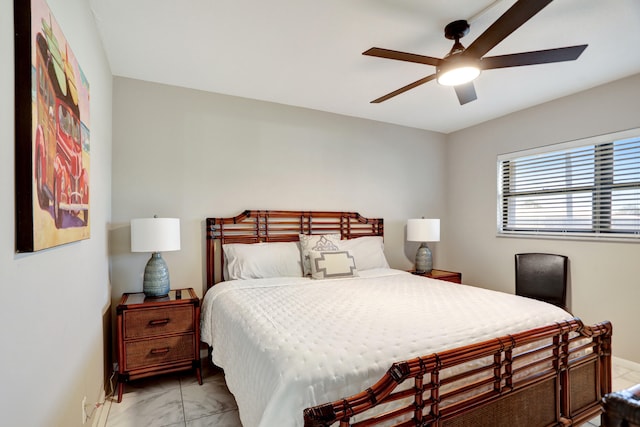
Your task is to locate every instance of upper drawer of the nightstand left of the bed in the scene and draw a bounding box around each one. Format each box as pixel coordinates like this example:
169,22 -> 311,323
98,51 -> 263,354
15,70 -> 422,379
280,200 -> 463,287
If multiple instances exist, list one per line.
124,305 -> 194,340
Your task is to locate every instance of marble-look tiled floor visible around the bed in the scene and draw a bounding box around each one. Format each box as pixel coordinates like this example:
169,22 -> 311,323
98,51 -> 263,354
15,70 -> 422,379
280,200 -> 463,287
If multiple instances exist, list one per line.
98,358 -> 640,427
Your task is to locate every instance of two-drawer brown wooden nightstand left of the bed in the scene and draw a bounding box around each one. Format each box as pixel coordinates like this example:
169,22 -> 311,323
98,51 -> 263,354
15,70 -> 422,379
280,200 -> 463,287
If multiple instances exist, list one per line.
116,288 -> 202,402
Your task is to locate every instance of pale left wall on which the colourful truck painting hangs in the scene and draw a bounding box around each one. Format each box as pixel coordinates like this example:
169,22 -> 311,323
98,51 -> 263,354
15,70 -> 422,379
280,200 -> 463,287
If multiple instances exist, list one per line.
0,0 -> 112,427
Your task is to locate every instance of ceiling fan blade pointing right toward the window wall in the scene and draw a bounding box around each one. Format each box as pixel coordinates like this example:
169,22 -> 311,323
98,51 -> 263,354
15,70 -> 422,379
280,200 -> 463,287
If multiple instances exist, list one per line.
480,44 -> 588,70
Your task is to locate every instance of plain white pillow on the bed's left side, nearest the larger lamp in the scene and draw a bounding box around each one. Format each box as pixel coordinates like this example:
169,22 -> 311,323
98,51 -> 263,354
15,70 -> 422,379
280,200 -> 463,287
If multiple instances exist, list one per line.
222,242 -> 302,280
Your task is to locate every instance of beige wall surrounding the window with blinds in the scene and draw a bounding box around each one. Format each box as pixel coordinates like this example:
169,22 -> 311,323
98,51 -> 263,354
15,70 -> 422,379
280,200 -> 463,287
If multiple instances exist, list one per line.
440,75 -> 640,362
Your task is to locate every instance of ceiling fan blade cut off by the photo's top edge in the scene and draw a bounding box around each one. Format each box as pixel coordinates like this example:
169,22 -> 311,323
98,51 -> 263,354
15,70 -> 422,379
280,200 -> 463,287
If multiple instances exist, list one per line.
464,0 -> 552,58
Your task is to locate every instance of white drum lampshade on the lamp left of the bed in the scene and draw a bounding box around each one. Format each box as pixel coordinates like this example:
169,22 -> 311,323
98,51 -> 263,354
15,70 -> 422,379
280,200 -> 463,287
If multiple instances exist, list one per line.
131,218 -> 180,252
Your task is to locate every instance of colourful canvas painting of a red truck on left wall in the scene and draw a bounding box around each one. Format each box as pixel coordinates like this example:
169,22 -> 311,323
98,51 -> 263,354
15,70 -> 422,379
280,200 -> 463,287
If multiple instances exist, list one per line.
14,0 -> 90,252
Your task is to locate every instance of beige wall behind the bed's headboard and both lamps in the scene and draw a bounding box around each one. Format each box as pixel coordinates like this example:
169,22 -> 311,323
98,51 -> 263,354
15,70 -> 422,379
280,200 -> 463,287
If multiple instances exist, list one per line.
111,77 -> 446,300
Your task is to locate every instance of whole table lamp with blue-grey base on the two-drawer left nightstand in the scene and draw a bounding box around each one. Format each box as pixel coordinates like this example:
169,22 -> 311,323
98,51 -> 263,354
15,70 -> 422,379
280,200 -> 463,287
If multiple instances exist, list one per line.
131,216 -> 180,297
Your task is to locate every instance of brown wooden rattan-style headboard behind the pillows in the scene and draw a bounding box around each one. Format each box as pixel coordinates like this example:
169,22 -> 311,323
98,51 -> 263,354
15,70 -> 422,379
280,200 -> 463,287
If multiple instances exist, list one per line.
205,211 -> 384,289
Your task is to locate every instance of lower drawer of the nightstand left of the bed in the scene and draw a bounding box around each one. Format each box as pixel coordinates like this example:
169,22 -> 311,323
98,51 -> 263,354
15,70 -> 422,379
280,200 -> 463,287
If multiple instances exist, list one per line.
124,334 -> 195,370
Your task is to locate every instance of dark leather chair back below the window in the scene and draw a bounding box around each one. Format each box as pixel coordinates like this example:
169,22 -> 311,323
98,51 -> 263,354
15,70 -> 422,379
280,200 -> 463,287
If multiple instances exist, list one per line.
516,253 -> 568,310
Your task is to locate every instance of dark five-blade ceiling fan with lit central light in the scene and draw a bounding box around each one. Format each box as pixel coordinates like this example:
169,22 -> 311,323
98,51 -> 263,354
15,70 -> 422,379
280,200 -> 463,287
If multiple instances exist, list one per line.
362,0 -> 588,105
